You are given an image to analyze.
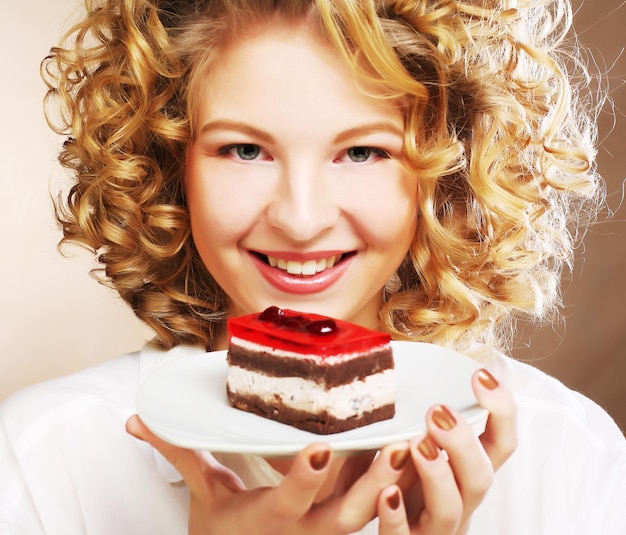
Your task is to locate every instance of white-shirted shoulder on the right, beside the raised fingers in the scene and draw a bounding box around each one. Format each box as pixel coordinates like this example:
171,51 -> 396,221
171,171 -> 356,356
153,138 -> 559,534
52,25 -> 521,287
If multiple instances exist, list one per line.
472,346 -> 626,534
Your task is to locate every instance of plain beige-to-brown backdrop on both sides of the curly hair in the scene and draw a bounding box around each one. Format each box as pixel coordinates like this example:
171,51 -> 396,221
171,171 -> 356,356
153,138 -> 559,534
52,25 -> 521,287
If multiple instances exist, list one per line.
0,0 -> 626,430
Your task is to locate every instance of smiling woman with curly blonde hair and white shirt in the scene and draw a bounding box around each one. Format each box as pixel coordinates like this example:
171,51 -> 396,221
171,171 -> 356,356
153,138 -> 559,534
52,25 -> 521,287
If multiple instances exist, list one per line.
0,0 -> 626,535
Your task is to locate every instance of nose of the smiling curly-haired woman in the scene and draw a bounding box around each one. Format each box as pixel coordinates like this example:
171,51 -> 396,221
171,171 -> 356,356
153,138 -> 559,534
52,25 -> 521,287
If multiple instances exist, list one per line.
267,163 -> 340,242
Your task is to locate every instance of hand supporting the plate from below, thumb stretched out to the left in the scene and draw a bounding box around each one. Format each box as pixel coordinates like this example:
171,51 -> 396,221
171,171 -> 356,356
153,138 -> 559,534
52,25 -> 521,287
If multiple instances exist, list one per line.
126,416 -> 414,535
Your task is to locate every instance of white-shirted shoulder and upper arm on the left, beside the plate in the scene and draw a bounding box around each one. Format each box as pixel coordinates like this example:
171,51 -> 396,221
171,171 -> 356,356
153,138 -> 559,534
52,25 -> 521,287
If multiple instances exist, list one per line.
0,349 -> 187,533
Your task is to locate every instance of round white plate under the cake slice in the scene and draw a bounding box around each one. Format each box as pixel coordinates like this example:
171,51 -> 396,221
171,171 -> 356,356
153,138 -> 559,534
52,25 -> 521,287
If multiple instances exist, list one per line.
137,342 -> 487,456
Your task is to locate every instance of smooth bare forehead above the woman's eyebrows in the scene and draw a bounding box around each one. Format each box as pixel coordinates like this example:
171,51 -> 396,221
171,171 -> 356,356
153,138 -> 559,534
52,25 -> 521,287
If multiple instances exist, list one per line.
193,20 -> 402,137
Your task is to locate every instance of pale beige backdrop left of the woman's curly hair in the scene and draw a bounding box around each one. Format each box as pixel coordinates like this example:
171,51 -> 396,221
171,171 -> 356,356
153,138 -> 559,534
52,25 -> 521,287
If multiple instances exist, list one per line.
0,0 -> 154,399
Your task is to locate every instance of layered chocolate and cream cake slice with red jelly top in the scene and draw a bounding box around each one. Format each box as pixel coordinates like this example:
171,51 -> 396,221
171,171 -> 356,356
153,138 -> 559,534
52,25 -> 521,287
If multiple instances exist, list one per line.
226,307 -> 396,434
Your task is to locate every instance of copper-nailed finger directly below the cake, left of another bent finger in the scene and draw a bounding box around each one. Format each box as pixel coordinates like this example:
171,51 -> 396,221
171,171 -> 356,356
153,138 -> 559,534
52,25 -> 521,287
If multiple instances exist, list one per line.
260,443 -> 332,524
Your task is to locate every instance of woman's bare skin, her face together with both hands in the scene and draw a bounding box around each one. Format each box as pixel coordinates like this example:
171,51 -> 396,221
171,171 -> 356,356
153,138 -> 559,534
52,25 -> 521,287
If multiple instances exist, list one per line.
127,16 -> 516,535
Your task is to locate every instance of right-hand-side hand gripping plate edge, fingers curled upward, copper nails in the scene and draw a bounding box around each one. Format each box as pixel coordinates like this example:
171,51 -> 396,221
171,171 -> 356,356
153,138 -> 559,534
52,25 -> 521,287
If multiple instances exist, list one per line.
377,370 -> 517,535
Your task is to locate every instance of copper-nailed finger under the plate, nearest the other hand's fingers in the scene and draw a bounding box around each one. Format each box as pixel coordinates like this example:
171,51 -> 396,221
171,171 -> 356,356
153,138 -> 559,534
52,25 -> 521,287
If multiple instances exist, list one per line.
327,442 -> 410,533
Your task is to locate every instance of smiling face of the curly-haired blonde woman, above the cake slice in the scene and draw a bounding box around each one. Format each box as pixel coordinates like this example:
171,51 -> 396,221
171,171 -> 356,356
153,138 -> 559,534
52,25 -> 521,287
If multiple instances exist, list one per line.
186,23 -> 417,327
